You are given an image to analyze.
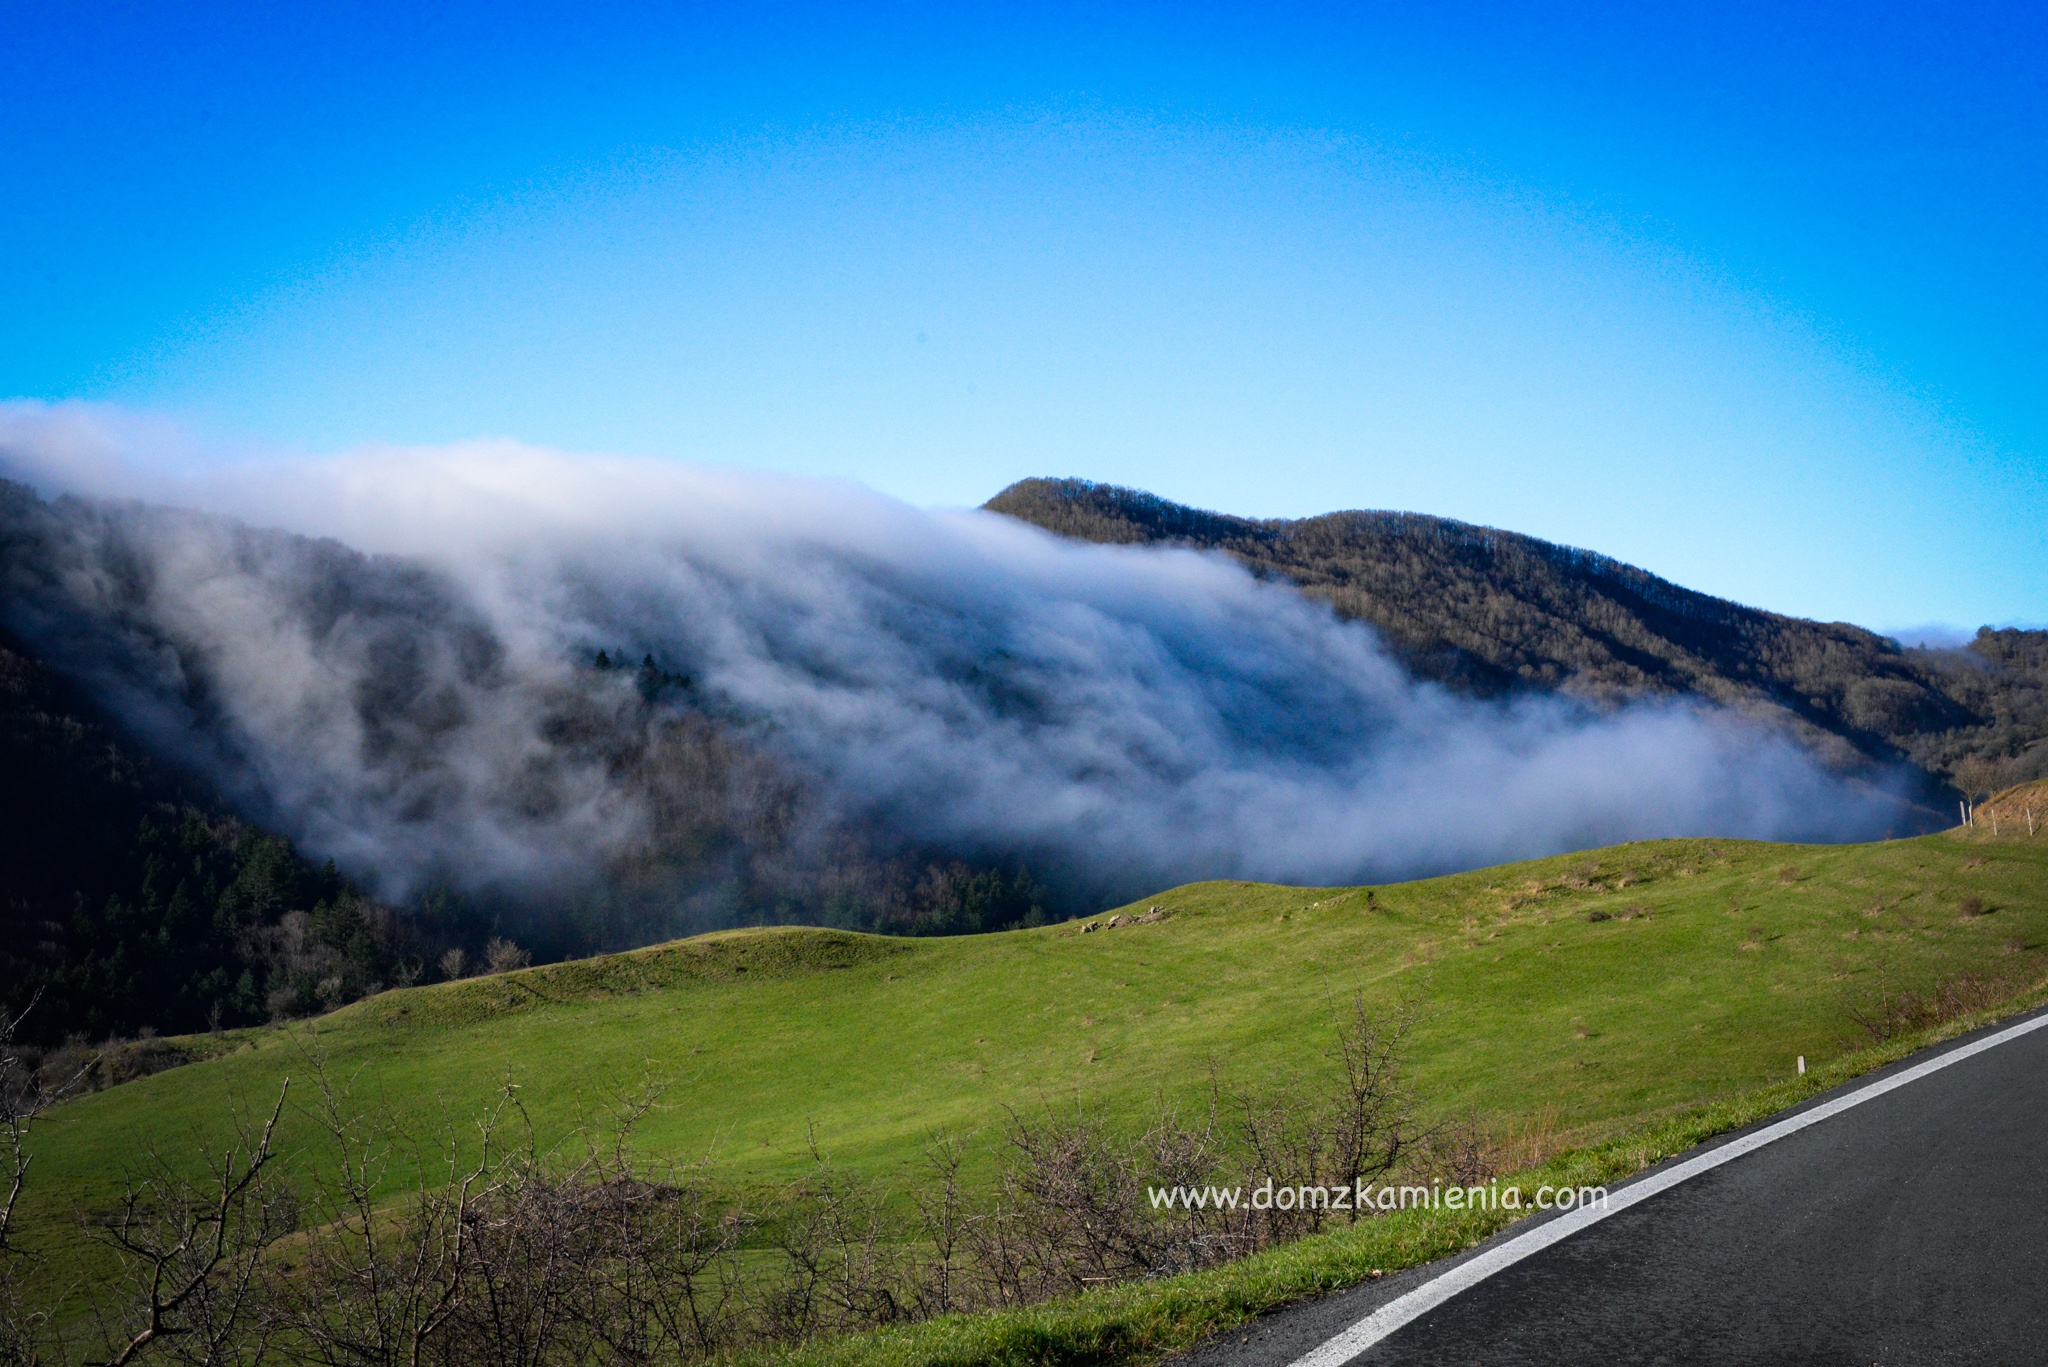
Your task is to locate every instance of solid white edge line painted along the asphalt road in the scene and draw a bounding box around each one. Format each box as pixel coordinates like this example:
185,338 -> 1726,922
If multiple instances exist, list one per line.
1292,1014 -> 2048,1367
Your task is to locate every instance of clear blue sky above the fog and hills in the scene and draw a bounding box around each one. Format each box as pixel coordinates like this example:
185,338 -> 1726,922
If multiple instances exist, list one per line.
0,2 -> 2048,629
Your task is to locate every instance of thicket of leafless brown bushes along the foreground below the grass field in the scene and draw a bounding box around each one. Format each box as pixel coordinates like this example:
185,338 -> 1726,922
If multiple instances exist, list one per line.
19,1002 -> 1458,1367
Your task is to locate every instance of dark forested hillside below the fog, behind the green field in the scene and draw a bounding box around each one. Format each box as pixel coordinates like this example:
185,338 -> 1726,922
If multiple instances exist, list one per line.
0,614 -> 1049,1043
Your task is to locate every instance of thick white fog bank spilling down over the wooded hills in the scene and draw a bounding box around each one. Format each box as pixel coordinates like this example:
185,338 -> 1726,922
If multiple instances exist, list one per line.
0,406 -> 1901,930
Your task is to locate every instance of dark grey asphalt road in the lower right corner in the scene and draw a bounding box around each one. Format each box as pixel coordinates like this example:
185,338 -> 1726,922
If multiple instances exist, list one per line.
1180,1004 -> 2048,1367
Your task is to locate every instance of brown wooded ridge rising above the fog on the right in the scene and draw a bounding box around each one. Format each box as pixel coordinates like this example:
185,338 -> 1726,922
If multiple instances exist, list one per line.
985,480 -> 2048,793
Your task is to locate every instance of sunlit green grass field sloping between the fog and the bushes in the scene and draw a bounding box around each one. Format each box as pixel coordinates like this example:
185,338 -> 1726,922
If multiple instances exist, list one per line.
23,832 -> 2048,1344
